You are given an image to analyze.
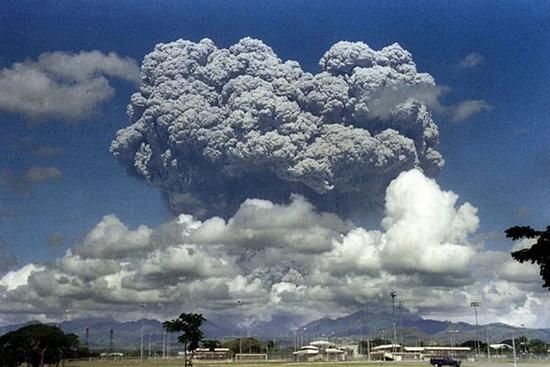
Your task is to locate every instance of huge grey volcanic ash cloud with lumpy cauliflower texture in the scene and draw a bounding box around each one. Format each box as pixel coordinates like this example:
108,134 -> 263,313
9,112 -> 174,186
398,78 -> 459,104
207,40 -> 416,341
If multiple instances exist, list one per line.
111,38 -> 444,218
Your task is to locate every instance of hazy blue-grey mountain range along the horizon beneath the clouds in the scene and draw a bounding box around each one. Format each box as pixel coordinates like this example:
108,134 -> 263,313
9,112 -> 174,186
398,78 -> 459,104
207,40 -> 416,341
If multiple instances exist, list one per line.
1,309 -> 550,351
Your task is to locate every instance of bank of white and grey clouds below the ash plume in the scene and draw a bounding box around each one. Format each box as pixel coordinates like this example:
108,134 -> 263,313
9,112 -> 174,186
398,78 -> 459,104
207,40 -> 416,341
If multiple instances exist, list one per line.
0,169 -> 549,330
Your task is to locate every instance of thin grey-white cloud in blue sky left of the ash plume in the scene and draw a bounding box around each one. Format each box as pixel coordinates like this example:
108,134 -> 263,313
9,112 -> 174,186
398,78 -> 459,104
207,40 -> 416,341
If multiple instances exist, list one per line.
0,50 -> 140,121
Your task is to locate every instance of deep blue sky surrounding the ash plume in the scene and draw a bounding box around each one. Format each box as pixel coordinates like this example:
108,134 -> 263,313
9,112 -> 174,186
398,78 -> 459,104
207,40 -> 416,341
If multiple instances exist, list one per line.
0,1 -> 550,328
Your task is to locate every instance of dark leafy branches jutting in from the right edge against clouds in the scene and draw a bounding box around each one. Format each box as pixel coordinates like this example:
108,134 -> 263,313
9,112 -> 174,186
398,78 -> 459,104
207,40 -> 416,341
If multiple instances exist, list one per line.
505,226 -> 550,289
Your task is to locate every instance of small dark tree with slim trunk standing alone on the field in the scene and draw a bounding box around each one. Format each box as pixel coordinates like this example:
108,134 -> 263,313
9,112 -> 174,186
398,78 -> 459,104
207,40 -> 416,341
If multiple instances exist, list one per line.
162,313 -> 206,367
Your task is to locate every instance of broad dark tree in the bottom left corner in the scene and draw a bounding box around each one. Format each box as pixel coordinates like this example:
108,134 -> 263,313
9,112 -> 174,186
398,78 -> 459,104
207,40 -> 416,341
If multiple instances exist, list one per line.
0,324 -> 79,367
